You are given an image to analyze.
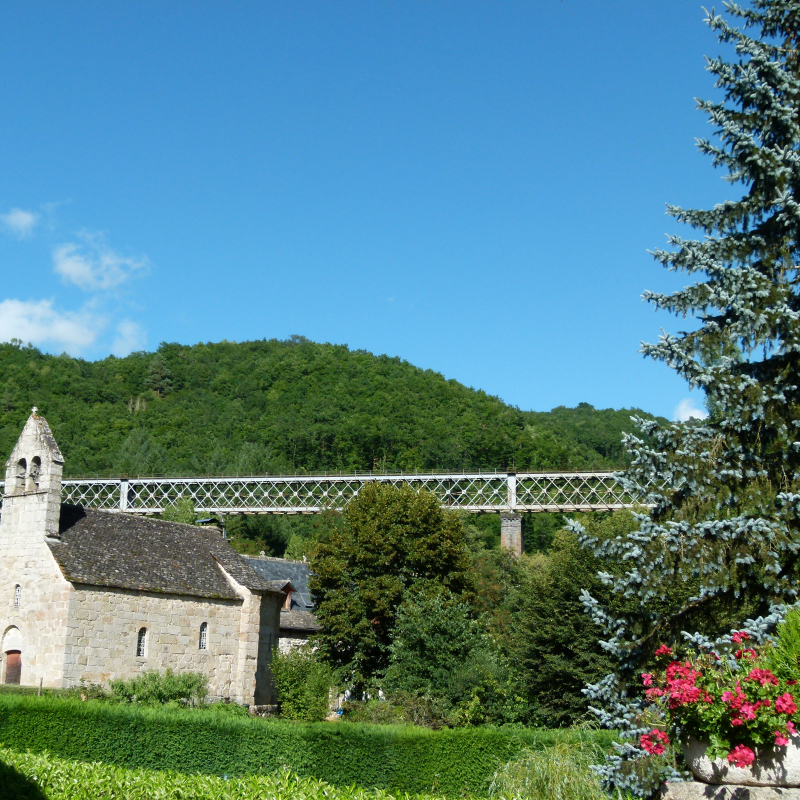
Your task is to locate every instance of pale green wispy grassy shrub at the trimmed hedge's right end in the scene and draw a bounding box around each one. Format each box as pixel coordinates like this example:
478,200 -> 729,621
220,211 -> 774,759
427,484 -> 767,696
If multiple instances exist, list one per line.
490,742 -> 608,800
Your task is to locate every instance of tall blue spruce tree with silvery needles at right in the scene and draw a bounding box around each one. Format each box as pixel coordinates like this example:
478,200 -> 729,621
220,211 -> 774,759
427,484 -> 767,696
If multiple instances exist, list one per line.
573,0 -> 800,796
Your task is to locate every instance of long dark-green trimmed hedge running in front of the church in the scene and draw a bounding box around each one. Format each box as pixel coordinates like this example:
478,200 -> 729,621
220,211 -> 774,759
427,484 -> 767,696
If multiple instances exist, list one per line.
0,695 -> 613,798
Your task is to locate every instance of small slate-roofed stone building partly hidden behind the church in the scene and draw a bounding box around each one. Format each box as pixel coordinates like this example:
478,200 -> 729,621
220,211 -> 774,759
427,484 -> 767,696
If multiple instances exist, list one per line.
246,556 -> 319,653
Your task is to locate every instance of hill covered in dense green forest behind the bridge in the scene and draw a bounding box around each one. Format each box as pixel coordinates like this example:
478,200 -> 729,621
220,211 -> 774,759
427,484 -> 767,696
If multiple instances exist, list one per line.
0,337 -> 664,476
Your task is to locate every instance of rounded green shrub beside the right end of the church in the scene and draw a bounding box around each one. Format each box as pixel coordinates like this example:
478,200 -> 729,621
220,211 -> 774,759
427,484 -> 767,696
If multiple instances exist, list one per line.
270,645 -> 333,722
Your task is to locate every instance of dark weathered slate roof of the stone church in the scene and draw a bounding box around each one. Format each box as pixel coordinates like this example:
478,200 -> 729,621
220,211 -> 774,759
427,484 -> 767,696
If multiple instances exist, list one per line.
48,504 -> 277,600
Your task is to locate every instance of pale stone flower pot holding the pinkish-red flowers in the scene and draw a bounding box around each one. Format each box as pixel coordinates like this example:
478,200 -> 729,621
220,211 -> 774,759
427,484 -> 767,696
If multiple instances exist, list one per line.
683,734 -> 800,786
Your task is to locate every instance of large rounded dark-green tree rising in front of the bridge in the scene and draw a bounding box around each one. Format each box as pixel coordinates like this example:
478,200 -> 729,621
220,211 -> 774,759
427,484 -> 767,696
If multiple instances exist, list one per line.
310,483 -> 469,691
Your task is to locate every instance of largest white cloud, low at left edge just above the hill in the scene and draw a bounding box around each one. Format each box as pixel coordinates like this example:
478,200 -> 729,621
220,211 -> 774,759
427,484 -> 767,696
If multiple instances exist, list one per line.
0,300 -> 105,355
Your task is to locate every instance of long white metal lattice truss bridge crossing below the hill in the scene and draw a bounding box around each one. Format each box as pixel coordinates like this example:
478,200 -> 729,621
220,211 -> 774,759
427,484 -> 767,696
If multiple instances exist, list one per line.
0,472 -> 635,514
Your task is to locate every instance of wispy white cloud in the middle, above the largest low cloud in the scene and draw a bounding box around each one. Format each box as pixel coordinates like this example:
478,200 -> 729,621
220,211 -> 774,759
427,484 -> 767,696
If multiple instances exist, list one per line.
53,233 -> 148,291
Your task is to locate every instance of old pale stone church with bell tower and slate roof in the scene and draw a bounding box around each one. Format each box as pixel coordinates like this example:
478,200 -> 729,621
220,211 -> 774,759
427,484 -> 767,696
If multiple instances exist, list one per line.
0,416 -> 287,705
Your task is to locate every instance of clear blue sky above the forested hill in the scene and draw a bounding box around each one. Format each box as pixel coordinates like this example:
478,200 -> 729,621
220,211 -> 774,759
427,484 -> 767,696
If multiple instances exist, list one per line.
0,0 -> 731,417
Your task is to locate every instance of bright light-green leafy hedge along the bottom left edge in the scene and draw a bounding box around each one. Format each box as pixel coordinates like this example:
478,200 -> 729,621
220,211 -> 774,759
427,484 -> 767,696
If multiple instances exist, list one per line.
0,748 -> 434,800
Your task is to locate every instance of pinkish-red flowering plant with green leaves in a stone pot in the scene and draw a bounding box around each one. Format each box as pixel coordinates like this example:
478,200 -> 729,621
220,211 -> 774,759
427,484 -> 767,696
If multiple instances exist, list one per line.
639,631 -> 800,767
